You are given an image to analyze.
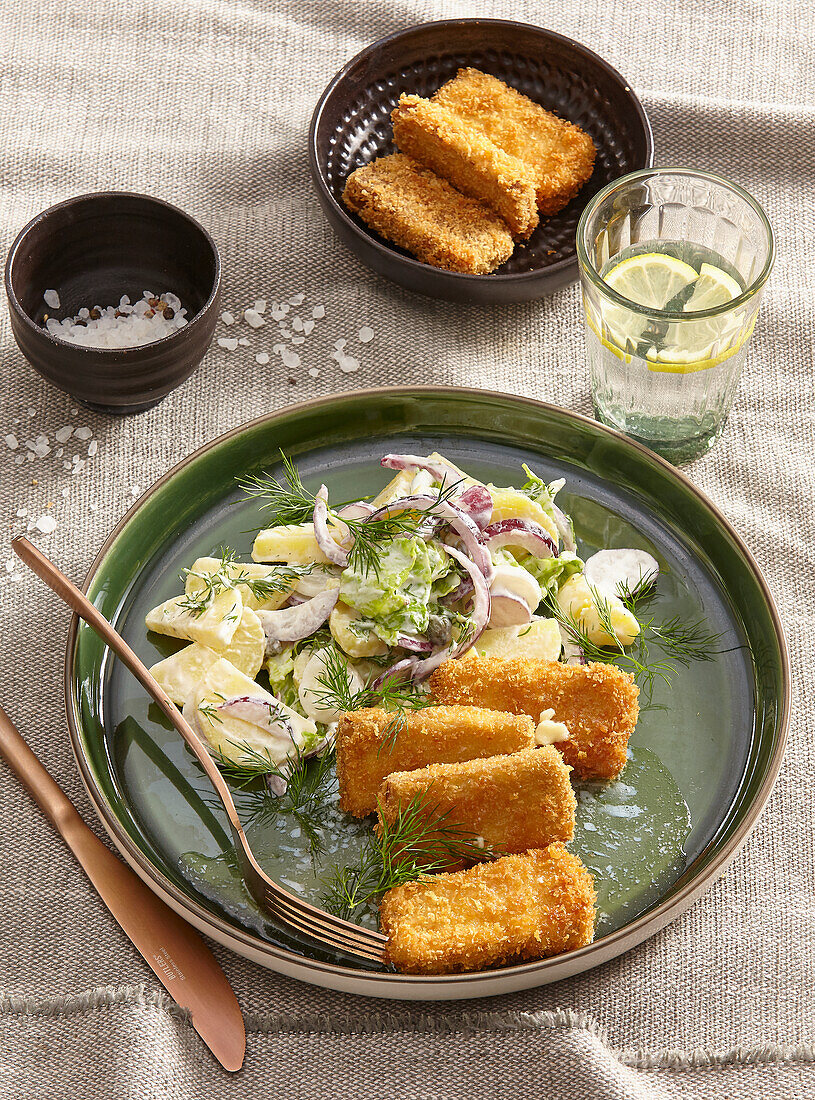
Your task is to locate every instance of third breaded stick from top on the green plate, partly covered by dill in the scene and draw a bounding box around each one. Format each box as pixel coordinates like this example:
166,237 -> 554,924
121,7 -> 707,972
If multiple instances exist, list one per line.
377,745 -> 576,869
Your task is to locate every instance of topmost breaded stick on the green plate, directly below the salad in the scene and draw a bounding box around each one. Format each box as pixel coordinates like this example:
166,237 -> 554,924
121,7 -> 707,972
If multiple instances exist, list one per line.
430,657 -> 639,779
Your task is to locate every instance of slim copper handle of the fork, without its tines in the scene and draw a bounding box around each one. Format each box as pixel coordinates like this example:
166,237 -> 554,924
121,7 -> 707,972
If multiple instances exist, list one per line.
11,535 -> 243,834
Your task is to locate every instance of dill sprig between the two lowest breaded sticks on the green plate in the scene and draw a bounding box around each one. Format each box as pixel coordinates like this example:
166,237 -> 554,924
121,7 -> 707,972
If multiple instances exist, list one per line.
320,794 -> 497,921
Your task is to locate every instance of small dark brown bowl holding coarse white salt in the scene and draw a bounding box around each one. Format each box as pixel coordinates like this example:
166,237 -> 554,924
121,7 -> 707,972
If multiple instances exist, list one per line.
5,191 -> 221,415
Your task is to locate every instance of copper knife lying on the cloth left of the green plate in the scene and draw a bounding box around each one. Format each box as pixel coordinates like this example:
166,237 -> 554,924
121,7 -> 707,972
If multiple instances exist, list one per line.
0,707 -> 246,1070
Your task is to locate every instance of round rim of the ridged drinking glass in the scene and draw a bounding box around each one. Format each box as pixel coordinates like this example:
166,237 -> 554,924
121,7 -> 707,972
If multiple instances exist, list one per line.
576,165 -> 775,322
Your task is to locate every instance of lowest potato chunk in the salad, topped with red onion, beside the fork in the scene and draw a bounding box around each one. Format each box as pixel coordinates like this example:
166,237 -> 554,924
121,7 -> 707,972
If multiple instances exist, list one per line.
184,658 -> 317,765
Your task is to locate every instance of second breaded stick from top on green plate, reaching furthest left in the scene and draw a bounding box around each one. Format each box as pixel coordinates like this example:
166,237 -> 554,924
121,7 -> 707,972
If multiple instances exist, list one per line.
337,706 -> 535,817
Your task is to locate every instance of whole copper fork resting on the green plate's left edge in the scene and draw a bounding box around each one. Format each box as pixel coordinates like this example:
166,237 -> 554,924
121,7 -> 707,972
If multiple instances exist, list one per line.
11,535 -> 385,963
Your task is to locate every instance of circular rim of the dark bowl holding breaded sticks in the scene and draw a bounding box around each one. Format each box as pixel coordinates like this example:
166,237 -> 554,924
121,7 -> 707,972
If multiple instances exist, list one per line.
308,17 -> 654,286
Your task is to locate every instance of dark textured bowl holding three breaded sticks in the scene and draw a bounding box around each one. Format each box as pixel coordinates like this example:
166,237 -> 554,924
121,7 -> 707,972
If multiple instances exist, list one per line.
309,19 -> 653,304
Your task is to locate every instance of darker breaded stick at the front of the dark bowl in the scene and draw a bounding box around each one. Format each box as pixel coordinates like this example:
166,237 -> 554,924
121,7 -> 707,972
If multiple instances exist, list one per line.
342,153 -> 515,275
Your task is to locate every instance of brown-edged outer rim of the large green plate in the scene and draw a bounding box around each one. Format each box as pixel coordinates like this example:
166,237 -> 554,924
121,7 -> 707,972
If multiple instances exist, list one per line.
64,386 -> 791,1000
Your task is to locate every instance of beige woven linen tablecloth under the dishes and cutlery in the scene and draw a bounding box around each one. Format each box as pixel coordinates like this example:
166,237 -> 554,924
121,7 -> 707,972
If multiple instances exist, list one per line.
0,0 -> 815,1100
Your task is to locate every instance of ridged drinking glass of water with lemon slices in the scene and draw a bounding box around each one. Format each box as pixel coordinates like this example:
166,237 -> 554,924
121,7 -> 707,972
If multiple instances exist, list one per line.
577,168 -> 773,465
